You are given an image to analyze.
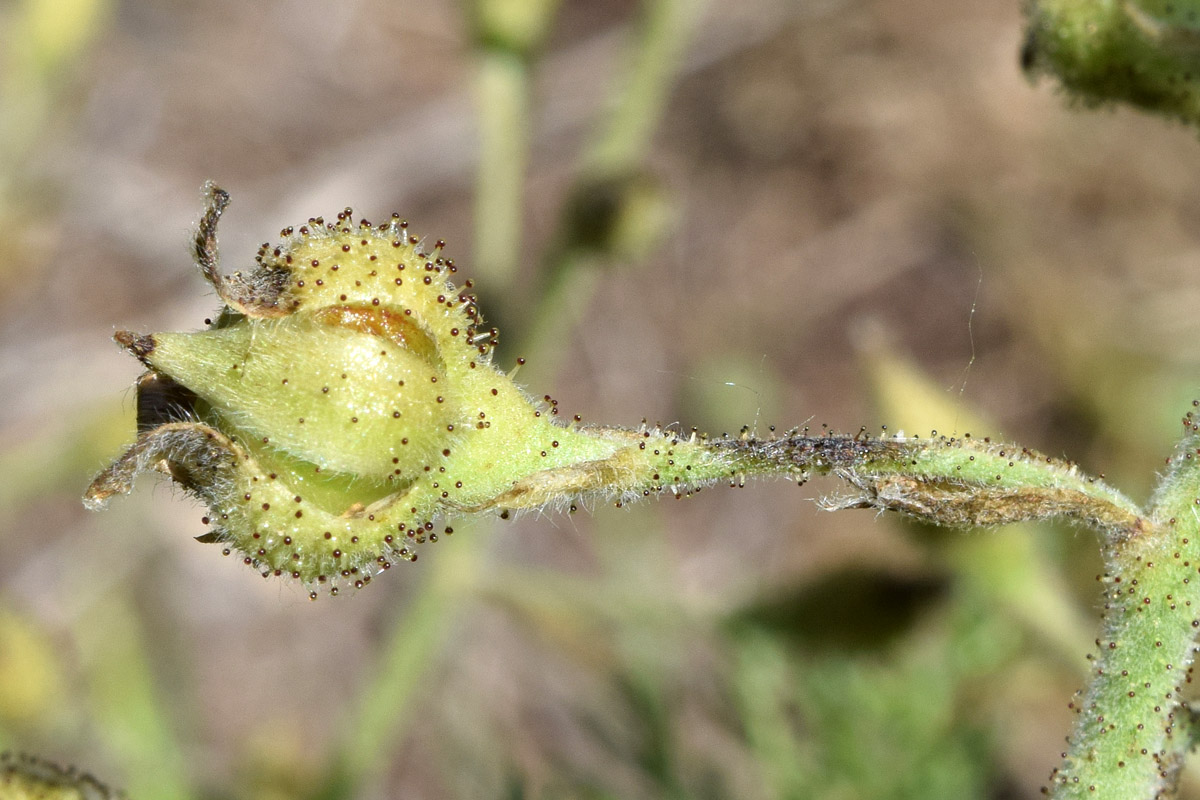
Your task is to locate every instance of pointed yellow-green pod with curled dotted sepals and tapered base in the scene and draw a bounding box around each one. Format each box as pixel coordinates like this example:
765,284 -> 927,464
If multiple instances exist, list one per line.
85,186 -> 724,587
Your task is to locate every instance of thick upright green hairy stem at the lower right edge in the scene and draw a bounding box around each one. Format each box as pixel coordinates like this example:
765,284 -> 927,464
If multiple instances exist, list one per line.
1052,414 -> 1200,799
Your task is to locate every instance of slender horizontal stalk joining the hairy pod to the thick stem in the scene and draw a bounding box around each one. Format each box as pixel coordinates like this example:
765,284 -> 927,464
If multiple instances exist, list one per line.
559,428 -> 1146,542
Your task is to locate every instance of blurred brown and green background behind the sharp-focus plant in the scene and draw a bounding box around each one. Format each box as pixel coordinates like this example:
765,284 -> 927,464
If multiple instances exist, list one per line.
0,0 -> 1200,800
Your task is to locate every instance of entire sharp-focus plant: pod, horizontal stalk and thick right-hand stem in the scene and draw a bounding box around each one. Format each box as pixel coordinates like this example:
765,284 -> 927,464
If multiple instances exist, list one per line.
84,185 -> 1200,799
